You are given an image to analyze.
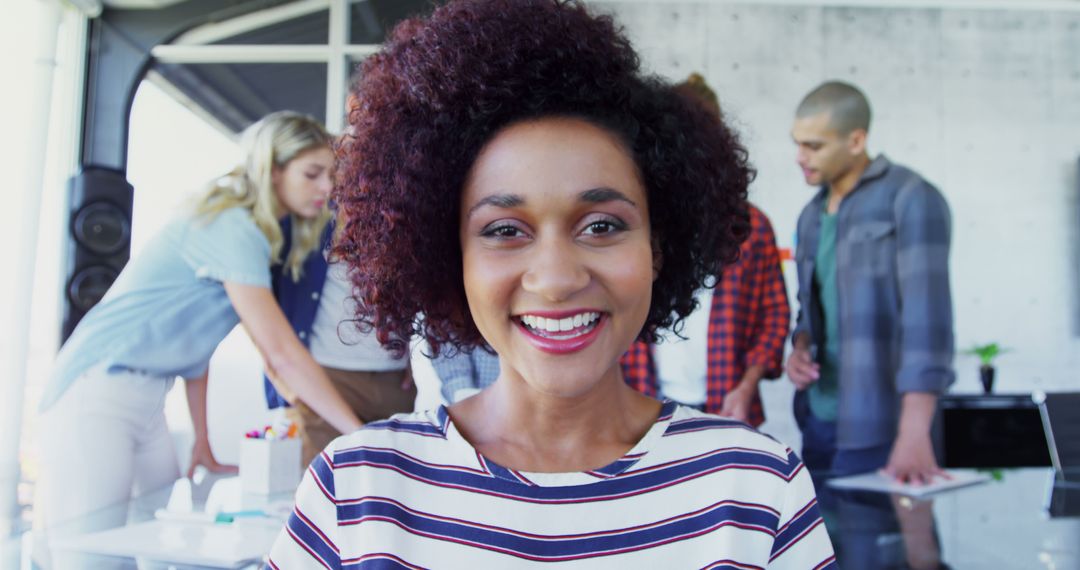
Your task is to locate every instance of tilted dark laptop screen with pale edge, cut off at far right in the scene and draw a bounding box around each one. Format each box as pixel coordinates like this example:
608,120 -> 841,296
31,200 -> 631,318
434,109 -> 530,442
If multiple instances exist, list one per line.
1031,392 -> 1080,486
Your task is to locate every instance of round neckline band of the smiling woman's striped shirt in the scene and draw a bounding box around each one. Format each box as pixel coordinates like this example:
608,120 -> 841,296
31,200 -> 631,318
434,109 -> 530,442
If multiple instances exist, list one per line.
437,399 -> 678,487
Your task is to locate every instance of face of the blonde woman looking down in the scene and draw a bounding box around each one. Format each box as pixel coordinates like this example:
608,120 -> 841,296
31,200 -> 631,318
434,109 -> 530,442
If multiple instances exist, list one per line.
272,147 -> 334,218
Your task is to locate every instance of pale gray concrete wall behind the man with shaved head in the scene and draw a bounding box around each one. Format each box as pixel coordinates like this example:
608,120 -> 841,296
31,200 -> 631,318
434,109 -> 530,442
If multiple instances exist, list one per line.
591,1 -> 1080,439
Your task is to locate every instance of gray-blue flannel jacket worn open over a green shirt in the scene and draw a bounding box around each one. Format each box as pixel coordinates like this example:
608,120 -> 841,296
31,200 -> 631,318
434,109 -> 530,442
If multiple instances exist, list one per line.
793,155 -> 956,449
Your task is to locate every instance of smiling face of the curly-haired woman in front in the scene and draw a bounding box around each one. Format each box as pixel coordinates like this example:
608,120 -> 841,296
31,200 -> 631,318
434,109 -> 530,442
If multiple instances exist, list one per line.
460,118 -> 654,397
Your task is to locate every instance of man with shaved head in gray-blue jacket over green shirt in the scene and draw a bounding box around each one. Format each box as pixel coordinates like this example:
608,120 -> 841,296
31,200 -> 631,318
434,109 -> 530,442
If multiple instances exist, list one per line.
787,82 -> 955,484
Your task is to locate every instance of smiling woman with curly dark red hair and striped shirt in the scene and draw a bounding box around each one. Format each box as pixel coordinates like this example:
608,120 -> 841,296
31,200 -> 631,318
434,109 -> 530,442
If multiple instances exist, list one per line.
270,0 -> 833,568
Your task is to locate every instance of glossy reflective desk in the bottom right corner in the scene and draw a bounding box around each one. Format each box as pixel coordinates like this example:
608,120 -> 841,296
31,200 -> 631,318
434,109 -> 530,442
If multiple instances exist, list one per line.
818,467 -> 1080,570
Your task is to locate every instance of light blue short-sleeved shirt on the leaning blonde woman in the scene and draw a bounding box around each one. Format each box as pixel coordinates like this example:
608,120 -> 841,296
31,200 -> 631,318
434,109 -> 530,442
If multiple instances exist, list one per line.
41,207 -> 270,409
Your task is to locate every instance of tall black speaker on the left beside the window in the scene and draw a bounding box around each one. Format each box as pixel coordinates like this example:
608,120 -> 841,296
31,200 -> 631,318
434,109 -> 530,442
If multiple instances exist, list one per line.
60,167 -> 135,342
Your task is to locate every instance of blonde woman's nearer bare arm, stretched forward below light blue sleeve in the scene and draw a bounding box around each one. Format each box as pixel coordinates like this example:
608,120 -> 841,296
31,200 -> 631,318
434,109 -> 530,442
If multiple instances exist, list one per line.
225,282 -> 361,434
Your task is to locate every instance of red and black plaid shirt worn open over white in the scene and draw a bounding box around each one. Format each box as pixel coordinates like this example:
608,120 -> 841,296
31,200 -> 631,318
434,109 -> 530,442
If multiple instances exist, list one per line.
621,205 -> 791,425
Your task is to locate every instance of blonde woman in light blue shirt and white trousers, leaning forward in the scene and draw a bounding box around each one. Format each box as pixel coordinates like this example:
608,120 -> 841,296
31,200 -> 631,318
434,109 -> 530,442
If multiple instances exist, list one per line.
40,112 -> 360,557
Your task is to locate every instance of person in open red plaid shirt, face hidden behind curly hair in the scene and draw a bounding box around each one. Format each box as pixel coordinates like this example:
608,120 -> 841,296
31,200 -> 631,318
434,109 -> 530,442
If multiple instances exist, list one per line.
622,73 -> 791,425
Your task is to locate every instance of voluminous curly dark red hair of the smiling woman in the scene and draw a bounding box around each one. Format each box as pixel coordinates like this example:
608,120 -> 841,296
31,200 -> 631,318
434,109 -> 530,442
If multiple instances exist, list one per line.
335,0 -> 754,354
